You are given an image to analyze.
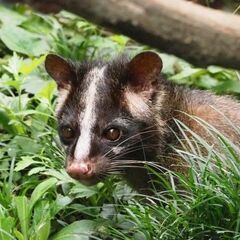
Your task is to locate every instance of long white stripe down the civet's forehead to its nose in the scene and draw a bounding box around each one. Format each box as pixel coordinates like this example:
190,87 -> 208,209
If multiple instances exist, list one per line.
74,67 -> 105,161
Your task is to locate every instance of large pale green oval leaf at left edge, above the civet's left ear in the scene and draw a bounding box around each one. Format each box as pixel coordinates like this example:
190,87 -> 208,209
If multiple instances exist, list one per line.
0,25 -> 50,56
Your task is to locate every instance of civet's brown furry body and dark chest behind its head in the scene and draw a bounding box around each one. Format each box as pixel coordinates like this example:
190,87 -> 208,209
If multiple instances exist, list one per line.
124,80 -> 240,193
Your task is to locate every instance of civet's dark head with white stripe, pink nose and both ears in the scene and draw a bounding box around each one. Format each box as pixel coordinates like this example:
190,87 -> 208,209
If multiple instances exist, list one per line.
45,52 -> 162,184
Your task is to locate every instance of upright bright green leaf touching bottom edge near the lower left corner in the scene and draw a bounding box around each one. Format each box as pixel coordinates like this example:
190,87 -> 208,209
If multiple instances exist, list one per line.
15,196 -> 30,240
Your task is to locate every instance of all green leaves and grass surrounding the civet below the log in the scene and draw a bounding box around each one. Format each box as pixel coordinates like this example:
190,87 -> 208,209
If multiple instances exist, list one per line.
0,5 -> 240,240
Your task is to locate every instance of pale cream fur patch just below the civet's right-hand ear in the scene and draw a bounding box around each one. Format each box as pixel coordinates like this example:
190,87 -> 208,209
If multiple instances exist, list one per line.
125,90 -> 151,119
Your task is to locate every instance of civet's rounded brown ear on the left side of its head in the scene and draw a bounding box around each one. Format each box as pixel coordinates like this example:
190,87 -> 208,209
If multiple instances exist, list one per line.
45,54 -> 76,89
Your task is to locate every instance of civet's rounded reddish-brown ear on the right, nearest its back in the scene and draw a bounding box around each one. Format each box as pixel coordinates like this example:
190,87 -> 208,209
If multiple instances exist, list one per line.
127,51 -> 162,92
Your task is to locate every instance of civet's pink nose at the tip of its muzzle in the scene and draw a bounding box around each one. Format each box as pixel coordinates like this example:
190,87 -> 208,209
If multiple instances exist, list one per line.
67,161 -> 94,180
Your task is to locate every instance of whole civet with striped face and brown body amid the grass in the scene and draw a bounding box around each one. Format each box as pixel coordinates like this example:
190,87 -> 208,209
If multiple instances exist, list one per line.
46,52 -> 240,190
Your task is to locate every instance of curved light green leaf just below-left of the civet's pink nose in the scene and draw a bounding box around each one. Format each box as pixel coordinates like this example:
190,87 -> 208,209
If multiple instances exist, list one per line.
30,178 -> 57,209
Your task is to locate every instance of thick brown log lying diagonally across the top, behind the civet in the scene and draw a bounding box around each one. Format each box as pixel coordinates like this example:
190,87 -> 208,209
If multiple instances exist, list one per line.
5,0 -> 240,69
